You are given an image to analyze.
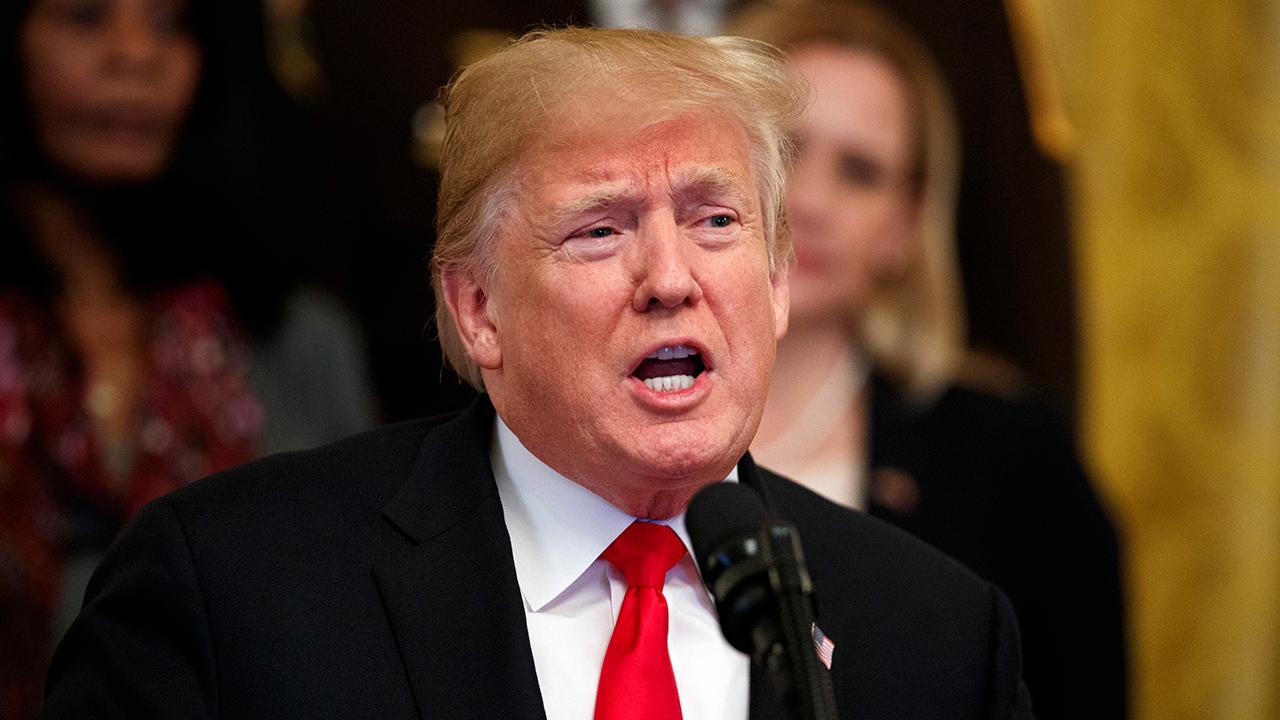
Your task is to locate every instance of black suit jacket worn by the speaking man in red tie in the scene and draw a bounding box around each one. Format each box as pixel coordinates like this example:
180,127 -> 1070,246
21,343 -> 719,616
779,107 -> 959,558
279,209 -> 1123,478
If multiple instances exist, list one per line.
45,401 -> 1030,720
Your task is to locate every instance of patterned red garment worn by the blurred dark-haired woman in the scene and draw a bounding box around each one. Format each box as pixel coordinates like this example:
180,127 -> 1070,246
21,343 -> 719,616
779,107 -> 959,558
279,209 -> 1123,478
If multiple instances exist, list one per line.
0,283 -> 262,717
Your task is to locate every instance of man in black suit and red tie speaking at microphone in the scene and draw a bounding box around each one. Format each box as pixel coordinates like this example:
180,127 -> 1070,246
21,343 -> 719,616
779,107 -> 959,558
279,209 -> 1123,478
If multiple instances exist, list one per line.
46,29 -> 1030,720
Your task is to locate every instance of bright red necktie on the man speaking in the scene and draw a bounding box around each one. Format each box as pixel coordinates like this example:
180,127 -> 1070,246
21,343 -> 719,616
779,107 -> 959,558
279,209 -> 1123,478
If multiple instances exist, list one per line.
595,523 -> 685,720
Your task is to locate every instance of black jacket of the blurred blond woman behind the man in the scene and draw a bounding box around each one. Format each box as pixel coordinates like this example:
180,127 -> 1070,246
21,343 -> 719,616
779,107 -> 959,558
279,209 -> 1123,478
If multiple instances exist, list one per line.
867,375 -> 1126,720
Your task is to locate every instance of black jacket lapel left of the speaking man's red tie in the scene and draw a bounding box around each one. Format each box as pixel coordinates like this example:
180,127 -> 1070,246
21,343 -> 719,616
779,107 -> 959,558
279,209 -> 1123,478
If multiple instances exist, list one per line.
374,398 -> 544,720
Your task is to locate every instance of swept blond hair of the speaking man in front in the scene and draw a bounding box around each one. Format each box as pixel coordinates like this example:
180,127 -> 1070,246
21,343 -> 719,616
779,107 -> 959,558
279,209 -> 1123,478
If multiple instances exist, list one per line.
431,28 -> 806,389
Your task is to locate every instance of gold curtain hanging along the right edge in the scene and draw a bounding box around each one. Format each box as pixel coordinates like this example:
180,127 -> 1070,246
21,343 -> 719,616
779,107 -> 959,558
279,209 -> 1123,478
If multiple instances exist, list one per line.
1024,0 -> 1280,720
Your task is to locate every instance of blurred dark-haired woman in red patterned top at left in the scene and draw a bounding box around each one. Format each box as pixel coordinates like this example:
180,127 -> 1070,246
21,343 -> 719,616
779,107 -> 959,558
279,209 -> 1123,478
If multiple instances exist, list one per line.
0,0 -> 371,717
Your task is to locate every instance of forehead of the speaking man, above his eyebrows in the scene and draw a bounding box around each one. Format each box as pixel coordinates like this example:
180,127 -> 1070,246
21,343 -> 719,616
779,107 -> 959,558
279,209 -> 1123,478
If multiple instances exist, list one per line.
520,113 -> 754,204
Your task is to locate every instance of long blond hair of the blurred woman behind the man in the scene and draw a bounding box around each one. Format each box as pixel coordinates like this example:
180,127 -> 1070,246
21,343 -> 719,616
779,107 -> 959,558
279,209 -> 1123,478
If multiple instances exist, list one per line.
733,0 -> 965,398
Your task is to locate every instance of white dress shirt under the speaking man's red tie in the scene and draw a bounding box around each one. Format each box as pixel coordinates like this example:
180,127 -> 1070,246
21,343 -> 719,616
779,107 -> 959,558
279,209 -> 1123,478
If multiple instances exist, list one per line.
490,418 -> 750,720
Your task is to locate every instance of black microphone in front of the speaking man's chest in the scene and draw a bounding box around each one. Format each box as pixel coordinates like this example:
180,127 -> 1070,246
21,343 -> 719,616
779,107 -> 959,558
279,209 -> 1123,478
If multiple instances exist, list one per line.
685,483 -> 837,720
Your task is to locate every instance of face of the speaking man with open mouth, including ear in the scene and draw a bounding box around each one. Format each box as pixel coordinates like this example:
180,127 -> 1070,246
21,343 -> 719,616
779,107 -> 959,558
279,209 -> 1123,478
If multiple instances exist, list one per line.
447,114 -> 787,516
